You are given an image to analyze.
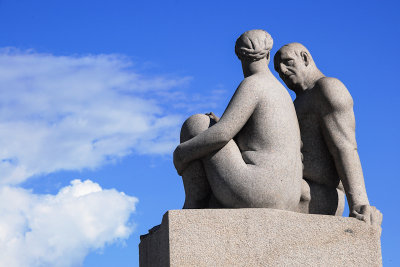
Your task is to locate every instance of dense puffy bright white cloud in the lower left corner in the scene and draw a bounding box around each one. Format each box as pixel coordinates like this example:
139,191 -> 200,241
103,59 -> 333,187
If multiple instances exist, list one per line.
0,180 -> 137,267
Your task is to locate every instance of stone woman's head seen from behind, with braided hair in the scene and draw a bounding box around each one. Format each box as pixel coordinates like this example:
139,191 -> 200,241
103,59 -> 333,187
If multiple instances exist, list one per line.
235,30 -> 273,62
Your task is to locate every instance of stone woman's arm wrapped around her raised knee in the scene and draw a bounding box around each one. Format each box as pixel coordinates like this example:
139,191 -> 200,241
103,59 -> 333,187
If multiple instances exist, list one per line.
174,80 -> 258,172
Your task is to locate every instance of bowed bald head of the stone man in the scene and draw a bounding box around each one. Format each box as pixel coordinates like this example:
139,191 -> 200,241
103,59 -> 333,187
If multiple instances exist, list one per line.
274,43 -> 317,91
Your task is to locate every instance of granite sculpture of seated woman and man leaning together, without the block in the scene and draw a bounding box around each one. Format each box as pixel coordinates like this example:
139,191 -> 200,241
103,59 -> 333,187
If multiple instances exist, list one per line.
173,30 -> 382,226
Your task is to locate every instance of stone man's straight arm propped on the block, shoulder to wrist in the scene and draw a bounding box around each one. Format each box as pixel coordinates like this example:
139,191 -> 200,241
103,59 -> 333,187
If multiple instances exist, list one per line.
317,78 -> 369,213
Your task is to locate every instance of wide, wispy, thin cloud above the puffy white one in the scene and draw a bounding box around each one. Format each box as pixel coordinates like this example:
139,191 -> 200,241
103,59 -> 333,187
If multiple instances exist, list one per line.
0,49 -> 190,184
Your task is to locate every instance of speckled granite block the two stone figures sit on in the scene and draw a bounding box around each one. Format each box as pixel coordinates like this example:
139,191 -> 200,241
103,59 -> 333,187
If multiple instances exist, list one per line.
139,209 -> 382,267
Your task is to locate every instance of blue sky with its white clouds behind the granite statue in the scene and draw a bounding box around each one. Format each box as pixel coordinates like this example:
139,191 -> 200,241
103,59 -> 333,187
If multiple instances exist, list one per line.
0,0 -> 400,267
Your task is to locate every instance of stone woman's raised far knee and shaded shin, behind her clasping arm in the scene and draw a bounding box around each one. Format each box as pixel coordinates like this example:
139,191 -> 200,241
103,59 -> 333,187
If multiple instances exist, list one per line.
180,114 -> 215,209
